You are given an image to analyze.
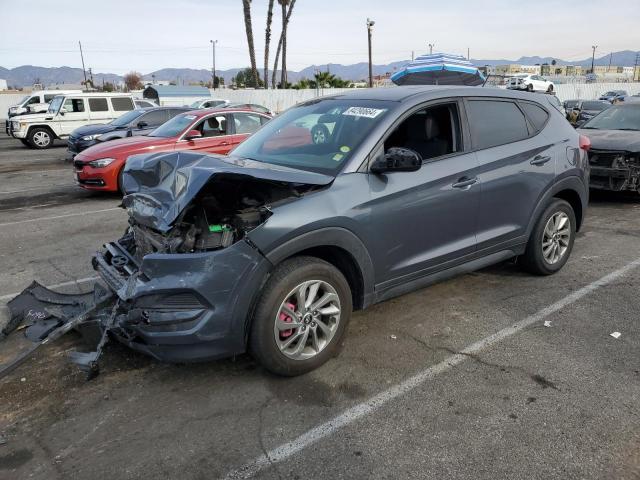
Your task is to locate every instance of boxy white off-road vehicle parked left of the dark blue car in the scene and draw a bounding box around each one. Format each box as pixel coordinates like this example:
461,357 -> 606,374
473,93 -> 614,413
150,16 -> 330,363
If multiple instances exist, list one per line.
9,93 -> 135,148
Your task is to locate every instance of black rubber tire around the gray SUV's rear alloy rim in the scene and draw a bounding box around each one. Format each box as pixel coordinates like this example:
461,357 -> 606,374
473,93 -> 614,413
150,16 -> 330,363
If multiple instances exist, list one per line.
519,198 -> 576,275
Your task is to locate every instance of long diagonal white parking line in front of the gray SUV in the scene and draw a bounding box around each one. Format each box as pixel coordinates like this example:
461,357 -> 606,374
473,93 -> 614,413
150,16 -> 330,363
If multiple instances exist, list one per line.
225,258 -> 640,480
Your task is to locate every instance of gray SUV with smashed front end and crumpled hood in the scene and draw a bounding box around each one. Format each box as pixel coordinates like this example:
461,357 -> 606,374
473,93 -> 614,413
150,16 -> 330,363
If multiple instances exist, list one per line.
93,87 -> 589,375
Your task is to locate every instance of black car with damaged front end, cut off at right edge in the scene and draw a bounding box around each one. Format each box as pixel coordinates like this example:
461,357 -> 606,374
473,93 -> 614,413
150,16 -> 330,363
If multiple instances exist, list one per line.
578,103 -> 640,192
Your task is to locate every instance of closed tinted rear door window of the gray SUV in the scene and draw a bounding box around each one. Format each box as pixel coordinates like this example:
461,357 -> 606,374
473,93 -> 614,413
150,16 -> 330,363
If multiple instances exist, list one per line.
467,100 -> 529,149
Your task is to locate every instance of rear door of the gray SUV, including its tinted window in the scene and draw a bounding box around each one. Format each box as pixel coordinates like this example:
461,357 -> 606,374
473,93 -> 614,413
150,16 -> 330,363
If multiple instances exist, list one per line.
465,98 -> 555,251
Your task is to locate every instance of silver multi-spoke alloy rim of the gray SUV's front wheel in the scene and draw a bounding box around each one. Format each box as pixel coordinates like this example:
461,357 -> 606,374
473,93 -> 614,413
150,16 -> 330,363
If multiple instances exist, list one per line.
273,280 -> 341,360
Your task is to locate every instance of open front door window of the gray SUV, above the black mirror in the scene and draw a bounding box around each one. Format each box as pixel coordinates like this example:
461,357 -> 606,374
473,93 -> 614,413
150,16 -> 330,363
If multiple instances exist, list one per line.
384,103 -> 462,160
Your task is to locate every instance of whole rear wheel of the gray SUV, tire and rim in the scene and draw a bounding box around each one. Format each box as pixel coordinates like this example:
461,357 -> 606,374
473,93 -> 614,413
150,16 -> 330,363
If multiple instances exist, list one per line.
521,199 -> 576,275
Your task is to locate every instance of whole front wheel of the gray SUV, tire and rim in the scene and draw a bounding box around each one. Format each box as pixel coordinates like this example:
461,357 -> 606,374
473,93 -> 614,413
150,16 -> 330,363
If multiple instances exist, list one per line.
249,257 -> 352,376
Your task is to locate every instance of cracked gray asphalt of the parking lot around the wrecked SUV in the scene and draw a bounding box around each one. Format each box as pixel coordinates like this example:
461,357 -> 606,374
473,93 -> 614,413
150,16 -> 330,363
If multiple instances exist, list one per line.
0,136 -> 640,480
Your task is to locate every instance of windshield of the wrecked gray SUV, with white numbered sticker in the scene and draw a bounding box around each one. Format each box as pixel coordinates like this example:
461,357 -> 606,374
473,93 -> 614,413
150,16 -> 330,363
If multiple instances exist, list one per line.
233,99 -> 394,175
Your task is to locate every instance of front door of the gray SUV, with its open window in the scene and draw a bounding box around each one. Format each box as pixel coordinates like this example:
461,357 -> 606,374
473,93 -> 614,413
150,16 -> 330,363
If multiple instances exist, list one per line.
367,101 -> 480,284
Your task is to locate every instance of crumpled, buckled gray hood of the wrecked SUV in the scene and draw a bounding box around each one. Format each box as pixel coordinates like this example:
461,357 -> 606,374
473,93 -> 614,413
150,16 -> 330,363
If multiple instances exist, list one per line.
122,152 -> 334,232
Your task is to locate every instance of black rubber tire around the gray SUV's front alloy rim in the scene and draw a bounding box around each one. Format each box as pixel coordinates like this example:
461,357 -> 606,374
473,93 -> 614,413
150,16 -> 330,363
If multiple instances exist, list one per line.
248,256 -> 353,377
